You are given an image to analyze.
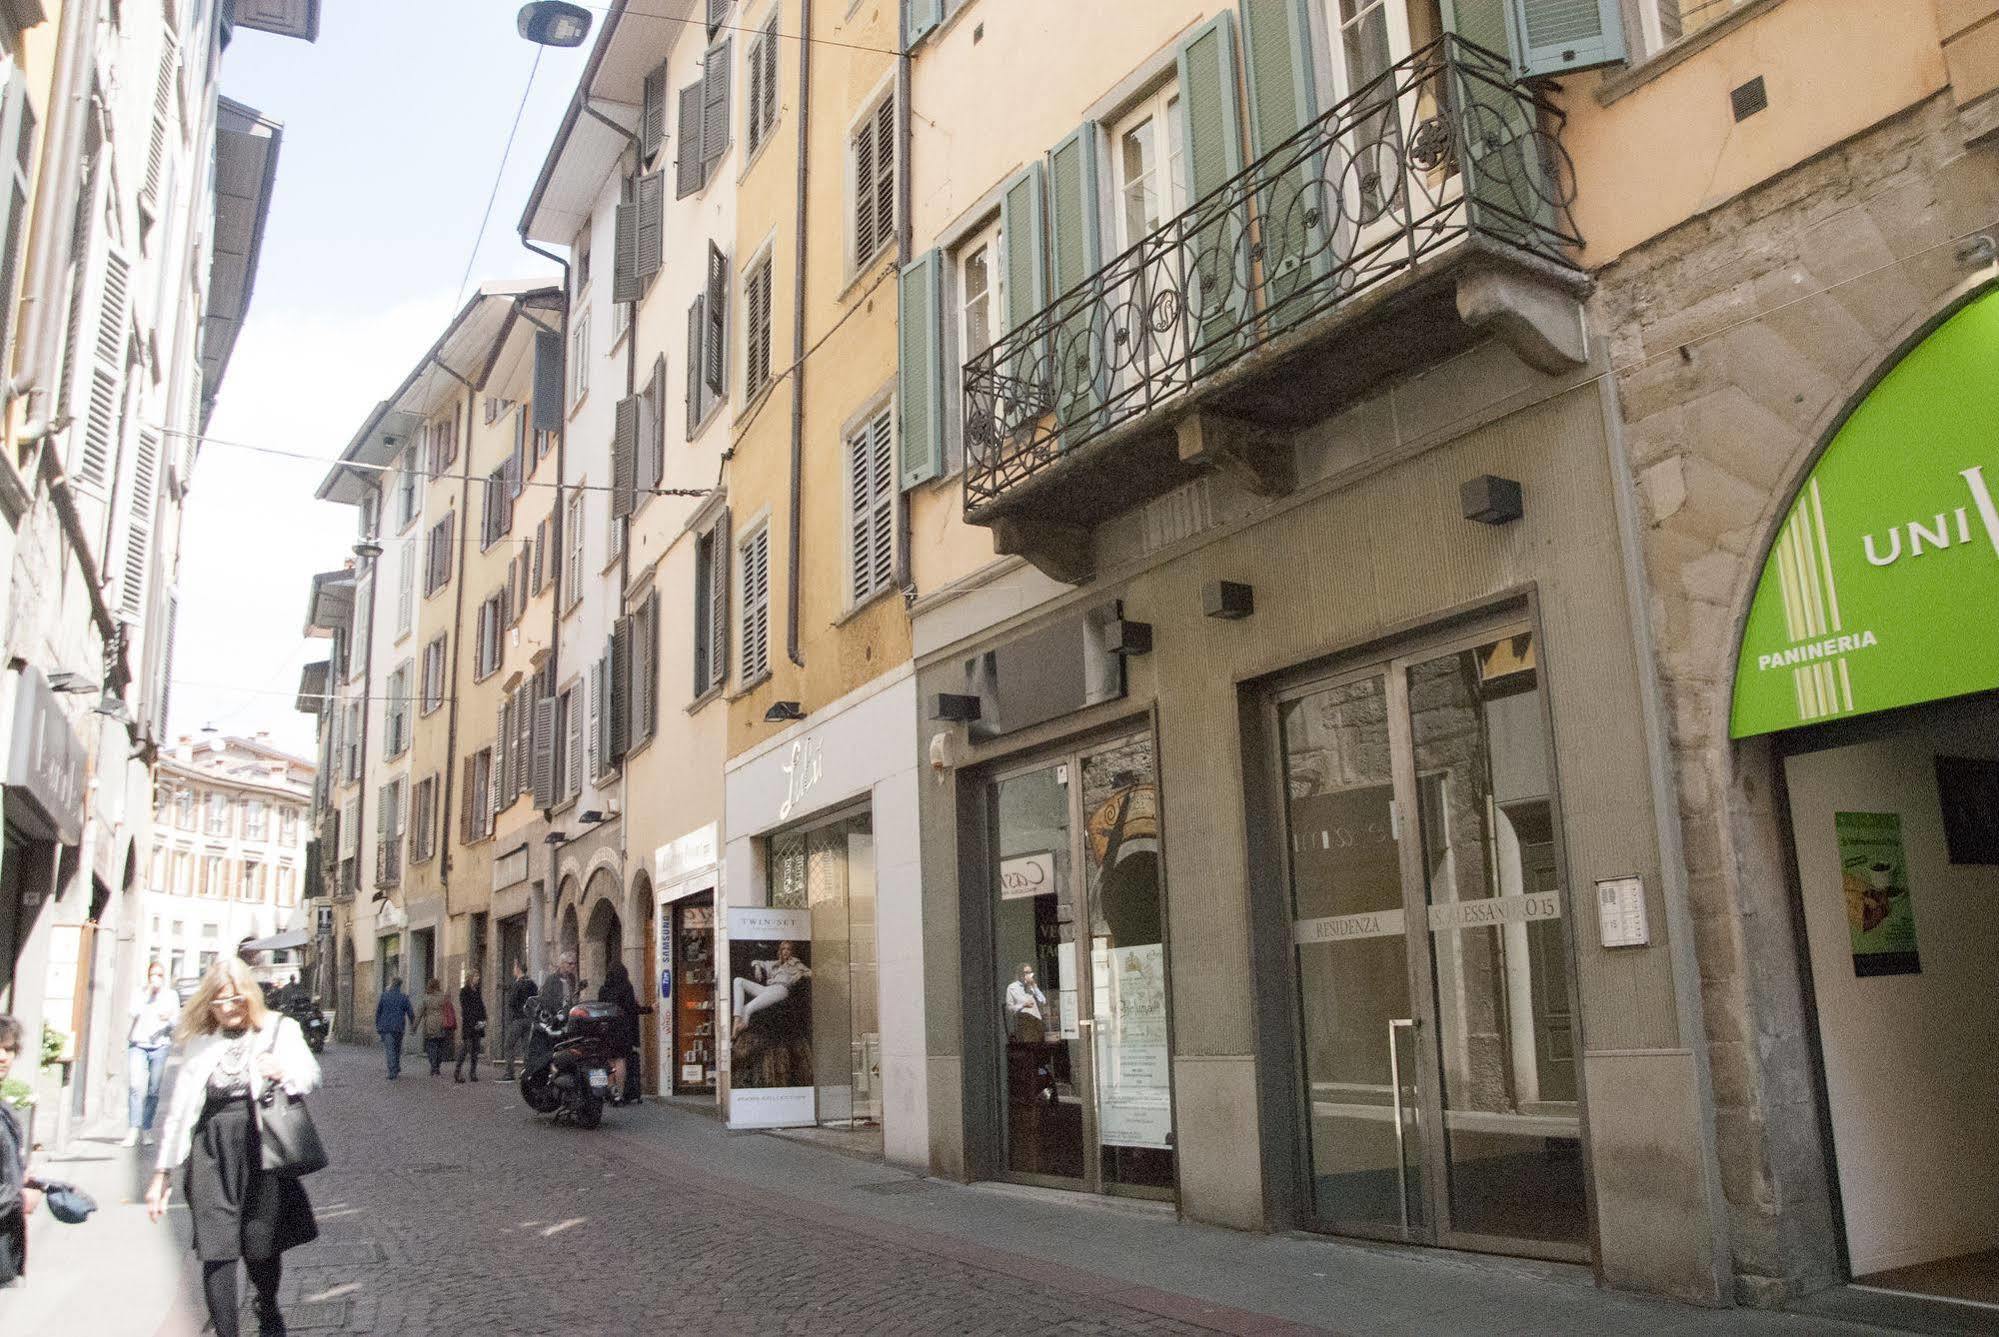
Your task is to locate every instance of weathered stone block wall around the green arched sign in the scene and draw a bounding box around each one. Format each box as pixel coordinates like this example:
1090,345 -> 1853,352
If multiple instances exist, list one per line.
1593,92 -> 1999,1303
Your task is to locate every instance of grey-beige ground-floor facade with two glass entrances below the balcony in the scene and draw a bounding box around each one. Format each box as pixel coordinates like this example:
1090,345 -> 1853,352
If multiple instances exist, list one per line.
914,344 -> 1721,1301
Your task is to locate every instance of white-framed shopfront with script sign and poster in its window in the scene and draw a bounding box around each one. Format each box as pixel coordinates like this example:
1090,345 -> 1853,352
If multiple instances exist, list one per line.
723,669 -> 928,1165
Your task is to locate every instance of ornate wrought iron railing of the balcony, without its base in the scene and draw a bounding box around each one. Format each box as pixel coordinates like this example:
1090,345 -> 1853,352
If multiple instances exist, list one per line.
964,36 -> 1581,522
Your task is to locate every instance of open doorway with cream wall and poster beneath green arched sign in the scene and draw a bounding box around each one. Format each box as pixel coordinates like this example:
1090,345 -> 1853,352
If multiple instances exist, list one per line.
1781,693 -> 1999,1305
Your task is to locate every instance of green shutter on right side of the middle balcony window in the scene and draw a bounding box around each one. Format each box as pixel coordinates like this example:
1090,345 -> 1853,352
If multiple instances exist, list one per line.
1179,10 -> 1249,366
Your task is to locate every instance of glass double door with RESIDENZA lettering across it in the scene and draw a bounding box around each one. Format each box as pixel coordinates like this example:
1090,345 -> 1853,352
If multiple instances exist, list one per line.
1271,626 -> 1589,1259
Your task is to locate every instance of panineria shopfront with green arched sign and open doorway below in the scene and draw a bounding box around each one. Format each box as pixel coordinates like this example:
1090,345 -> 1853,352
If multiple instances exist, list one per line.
1731,290 -> 1999,1305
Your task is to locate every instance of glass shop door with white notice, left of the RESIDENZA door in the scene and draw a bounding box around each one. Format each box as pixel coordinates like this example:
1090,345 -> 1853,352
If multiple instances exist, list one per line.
984,733 -> 1175,1197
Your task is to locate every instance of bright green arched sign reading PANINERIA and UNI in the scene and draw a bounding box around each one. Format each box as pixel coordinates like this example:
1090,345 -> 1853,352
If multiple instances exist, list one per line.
1729,292 -> 1999,737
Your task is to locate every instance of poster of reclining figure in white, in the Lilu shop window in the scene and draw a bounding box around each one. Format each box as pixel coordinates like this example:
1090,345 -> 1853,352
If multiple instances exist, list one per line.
728,905 -> 818,1127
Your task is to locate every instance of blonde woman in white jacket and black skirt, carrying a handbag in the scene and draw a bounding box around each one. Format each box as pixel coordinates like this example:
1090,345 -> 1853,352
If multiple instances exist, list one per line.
146,957 -> 320,1337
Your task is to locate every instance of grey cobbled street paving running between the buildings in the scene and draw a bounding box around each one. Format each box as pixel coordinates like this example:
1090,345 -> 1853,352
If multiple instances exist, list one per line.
0,1047 -> 1895,1337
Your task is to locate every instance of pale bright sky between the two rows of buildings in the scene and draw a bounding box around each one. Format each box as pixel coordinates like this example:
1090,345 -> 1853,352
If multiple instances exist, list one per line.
168,0 -> 602,757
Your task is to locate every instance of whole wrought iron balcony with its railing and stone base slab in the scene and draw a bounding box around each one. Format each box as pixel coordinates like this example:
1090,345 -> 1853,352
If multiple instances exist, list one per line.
964,36 -> 1583,550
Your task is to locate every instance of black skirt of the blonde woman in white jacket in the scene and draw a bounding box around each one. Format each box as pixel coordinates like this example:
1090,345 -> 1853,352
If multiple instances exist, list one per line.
188,1095 -> 320,1263
